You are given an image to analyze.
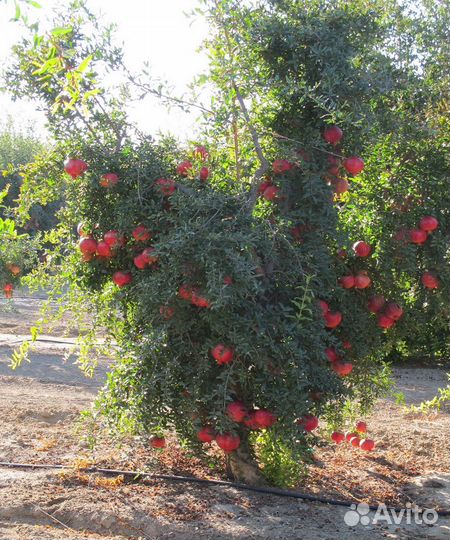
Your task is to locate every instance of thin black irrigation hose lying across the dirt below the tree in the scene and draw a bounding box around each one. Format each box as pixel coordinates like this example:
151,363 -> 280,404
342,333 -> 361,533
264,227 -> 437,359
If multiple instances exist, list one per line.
0,461 -> 450,516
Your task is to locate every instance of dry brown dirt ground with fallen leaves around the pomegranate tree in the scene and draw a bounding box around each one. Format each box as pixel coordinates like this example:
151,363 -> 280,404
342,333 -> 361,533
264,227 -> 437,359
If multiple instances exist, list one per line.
0,298 -> 450,540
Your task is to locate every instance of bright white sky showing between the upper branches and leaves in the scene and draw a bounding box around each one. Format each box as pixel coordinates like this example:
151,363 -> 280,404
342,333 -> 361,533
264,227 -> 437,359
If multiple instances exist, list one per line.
0,0 -> 208,139
